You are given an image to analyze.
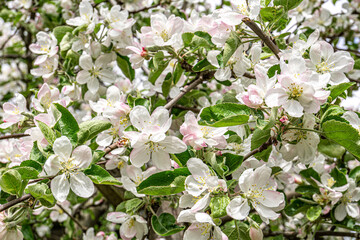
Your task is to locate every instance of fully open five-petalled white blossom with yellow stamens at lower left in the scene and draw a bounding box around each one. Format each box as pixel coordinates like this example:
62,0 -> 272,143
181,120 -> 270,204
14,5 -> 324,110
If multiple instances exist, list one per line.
44,136 -> 95,202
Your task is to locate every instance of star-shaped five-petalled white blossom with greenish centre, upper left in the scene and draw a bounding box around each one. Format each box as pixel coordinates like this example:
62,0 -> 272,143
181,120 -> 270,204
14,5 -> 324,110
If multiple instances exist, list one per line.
76,54 -> 115,94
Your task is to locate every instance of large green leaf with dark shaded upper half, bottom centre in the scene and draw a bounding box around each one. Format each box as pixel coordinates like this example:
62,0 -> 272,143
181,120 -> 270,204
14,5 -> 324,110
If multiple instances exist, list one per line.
137,168 -> 190,196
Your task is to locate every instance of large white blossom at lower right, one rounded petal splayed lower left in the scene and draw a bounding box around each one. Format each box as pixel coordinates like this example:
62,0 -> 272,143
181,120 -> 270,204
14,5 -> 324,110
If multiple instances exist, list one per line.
226,165 -> 284,223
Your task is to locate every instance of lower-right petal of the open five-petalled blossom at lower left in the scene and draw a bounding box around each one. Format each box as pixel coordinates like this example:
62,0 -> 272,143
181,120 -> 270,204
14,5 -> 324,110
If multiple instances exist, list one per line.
70,172 -> 95,198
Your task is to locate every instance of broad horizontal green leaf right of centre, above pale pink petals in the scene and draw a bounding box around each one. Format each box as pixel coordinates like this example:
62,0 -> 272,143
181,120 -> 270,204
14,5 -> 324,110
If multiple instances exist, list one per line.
200,103 -> 250,127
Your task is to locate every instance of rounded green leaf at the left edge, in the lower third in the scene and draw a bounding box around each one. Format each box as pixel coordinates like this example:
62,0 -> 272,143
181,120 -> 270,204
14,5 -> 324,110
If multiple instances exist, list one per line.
0,169 -> 21,195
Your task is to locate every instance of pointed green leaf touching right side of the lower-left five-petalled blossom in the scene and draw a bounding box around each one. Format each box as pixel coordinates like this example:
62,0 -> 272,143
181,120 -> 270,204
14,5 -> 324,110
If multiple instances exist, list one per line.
84,164 -> 121,185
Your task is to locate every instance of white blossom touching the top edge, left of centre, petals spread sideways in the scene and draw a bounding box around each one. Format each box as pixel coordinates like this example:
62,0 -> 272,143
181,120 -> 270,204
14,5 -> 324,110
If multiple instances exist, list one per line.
66,0 -> 98,34
